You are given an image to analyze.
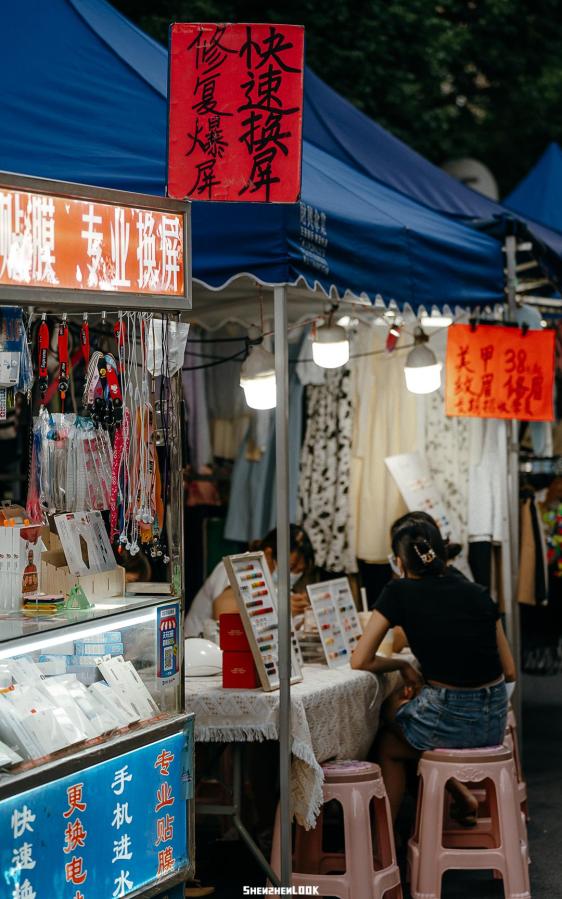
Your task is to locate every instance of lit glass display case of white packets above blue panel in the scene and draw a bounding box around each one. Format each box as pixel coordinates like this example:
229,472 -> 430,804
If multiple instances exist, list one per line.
0,596 -> 182,797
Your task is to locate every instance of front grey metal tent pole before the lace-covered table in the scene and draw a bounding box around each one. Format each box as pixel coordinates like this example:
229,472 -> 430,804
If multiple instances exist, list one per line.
273,285 -> 292,887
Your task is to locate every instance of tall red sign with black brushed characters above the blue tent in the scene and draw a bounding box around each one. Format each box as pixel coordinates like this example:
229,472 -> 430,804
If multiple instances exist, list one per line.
168,23 -> 304,203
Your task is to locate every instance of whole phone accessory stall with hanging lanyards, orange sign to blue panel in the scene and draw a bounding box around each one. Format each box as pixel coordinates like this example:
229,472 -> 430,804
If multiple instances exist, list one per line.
0,173 -> 194,899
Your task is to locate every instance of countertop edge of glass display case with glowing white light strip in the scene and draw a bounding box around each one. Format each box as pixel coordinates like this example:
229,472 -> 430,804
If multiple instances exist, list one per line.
0,595 -> 177,659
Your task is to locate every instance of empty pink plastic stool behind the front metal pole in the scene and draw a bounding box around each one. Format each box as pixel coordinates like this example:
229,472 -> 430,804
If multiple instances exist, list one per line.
271,761 -> 402,899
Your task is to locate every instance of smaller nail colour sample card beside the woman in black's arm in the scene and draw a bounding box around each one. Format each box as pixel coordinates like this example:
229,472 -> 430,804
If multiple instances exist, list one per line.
306,577 -> 362,668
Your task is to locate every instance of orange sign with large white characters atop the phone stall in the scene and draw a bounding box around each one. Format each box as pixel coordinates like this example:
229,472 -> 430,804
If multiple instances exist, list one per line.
0,186 -> 186,297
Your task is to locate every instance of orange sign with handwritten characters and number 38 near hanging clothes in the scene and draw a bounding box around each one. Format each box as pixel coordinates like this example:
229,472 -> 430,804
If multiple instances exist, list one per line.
445,325 -> 554,421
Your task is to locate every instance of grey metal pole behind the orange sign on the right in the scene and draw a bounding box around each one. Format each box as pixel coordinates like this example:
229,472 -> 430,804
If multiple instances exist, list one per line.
504,234 -> 522,739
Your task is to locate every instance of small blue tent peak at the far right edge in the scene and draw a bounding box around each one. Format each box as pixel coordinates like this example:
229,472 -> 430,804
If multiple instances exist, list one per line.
504,142 -> 562,232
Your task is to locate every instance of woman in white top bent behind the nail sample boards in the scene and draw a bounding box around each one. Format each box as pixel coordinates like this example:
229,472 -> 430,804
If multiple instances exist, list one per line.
185,524 -> 314,637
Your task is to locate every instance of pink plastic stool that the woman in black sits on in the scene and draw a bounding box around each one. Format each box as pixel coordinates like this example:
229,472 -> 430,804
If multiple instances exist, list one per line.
408,746 -> 531,899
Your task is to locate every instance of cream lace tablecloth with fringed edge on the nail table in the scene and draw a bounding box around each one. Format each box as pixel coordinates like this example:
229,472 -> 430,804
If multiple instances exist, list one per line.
185,665 -> 397,828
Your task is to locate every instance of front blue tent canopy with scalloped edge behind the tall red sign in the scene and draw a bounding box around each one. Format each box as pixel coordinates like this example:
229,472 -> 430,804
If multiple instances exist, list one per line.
0,0 -> 502,305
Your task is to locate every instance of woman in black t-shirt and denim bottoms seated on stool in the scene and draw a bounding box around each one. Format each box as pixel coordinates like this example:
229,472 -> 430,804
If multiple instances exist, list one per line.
351,519 -> 515,826
